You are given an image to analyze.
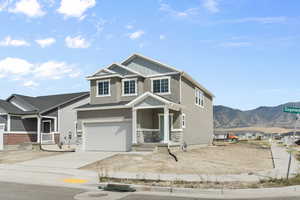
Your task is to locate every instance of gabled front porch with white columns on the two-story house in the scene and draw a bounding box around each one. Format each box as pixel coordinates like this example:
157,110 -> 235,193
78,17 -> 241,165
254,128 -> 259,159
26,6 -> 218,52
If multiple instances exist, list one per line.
132,94 -> 183,145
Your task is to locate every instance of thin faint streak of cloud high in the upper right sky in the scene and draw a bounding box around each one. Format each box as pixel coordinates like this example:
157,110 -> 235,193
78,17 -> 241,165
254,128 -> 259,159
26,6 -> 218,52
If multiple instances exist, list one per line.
229,17 -> 287,24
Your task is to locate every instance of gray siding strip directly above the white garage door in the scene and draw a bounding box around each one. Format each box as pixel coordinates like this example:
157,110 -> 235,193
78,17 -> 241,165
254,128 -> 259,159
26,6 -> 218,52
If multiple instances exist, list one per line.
77,108 -> 132,130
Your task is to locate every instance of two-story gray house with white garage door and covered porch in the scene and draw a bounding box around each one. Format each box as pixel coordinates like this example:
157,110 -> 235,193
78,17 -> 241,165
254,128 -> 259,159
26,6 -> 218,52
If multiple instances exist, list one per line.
76,54 -> 213,151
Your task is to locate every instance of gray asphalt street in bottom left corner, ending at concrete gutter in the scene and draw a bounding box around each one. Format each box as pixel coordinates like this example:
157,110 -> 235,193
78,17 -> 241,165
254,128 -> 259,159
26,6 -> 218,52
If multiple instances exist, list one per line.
0,182 -> 85,200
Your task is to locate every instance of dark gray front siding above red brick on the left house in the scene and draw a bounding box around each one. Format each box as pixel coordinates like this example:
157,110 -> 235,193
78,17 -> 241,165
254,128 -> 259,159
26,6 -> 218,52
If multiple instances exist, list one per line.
10,116 -> 37,133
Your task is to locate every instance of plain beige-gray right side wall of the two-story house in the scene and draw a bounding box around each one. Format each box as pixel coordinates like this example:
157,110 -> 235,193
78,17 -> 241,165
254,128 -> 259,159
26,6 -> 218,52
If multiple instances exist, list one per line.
181,78 -> 213,145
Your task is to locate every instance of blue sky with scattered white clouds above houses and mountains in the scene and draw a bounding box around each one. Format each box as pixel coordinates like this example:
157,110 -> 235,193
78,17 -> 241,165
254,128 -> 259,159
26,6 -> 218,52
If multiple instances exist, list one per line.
0,0 -> 300,110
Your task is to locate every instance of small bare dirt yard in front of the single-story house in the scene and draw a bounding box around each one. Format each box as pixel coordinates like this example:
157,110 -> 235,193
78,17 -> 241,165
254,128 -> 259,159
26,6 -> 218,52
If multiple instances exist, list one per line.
0,151 -> 61,164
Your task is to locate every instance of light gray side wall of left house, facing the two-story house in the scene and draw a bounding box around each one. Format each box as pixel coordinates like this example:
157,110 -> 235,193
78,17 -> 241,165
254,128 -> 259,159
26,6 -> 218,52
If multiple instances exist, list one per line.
58,98 -> 90,141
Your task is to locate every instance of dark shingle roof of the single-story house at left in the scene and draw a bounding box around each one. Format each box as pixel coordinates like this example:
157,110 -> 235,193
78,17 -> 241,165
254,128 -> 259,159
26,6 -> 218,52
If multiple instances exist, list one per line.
6,92 -> 90,114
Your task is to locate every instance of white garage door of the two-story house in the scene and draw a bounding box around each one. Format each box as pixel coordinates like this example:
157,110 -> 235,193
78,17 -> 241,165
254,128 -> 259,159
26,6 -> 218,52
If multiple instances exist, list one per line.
83,121 -> 132,151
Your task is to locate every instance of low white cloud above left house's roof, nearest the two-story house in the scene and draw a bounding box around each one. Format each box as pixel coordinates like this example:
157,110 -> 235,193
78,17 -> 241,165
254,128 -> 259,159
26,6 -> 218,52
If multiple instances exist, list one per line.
34,61 -> 73,79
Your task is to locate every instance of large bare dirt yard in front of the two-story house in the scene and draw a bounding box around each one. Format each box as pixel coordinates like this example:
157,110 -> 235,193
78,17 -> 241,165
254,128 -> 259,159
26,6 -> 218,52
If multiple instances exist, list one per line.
82,144 -> 273,175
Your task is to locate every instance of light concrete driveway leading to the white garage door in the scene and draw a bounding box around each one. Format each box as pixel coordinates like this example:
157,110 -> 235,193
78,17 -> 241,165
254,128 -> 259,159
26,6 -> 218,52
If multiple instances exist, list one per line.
19,152 -> 117,169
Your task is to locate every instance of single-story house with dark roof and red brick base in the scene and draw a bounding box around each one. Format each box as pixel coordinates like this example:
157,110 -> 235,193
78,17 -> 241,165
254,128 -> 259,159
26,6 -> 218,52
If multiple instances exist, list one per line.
0,92 -> 89,148
